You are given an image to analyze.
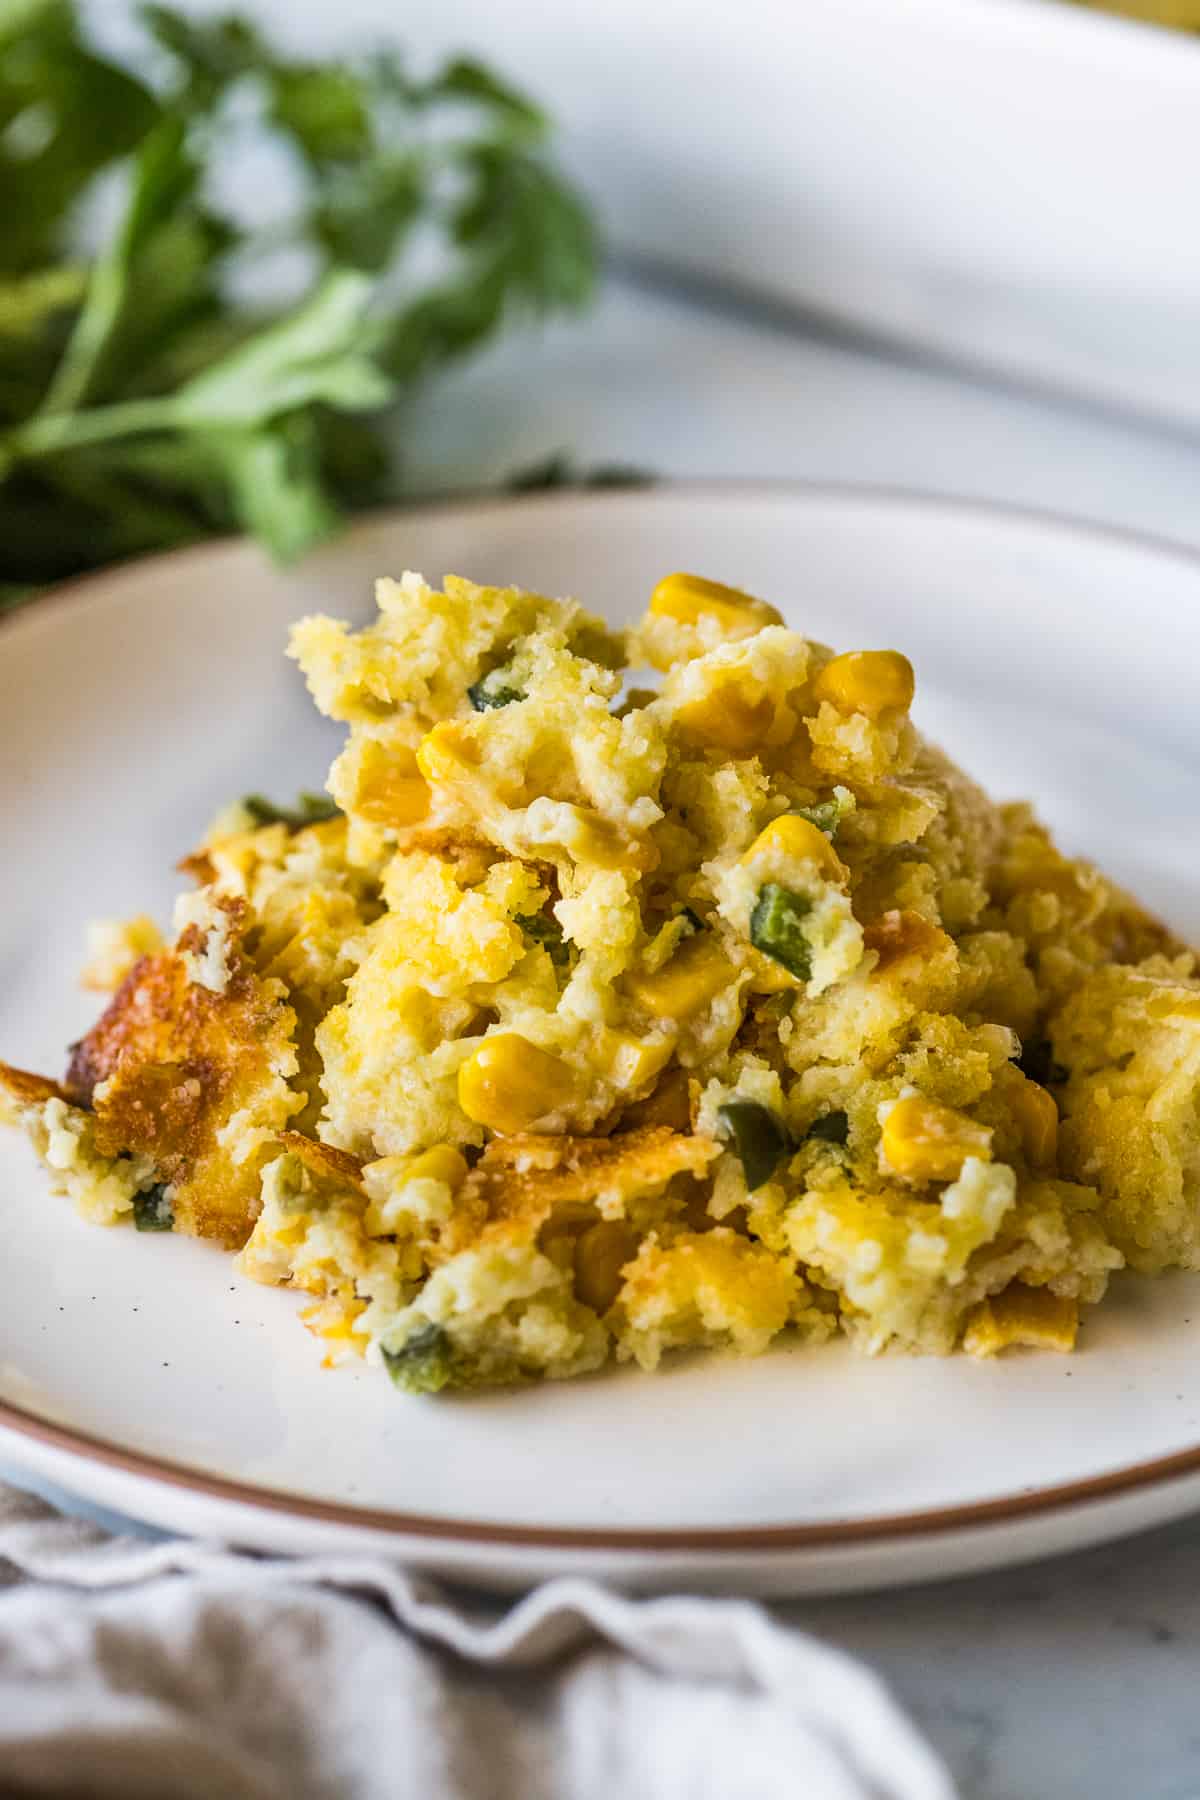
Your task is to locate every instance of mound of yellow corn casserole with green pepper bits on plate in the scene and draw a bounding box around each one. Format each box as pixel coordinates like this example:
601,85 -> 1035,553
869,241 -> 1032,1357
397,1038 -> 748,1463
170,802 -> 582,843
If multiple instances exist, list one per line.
0,574 -> 1200,1393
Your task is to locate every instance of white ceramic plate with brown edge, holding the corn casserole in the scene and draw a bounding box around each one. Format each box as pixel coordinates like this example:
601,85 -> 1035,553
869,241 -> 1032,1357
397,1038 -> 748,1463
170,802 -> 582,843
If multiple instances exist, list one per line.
0,486 -> 1200,1593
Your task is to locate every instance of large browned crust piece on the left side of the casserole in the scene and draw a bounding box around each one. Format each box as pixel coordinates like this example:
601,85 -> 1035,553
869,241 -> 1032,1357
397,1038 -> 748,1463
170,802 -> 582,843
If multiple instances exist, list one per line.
65,900 -> 295,1249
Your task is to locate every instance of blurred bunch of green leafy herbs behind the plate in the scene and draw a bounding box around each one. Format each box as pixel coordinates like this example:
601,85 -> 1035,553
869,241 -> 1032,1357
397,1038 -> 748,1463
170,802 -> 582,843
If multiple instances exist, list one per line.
0,0 -> 596,605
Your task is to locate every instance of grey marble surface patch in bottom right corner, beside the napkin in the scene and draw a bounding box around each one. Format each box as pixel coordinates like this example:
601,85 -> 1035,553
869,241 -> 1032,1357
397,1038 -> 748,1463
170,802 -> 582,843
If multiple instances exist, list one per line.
781,1521 -> 1200,1800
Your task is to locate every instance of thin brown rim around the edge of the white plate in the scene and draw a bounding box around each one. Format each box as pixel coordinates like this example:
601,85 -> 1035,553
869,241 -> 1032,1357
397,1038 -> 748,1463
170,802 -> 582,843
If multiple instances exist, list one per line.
9,477 -> 1200,1555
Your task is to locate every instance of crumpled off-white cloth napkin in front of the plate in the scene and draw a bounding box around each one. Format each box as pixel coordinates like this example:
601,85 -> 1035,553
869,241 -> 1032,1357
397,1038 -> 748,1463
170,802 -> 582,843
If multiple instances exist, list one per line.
0,1487 -> 952,1800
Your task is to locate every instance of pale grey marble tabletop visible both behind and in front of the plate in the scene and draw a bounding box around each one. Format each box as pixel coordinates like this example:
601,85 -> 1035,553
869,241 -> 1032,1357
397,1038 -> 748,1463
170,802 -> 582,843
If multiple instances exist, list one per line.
18,270 -> 1200,1800
